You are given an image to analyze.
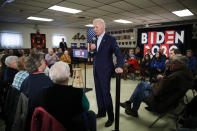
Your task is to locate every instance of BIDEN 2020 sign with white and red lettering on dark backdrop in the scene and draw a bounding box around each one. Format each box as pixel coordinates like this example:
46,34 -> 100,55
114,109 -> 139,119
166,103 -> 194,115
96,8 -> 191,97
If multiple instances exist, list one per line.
138,26 -> 192,57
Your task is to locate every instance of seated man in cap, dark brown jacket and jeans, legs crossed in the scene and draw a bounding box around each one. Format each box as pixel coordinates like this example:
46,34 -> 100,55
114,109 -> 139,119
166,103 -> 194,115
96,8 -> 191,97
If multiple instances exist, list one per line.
120,55 -> 193,117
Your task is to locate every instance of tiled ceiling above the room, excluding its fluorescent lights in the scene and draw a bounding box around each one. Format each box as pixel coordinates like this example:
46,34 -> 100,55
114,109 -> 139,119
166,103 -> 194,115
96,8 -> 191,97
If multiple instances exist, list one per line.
0,0 -> 197,28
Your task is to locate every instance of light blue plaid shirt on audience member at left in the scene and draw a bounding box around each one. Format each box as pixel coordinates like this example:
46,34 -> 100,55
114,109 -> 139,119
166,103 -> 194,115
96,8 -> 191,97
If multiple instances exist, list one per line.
12,70 -> 29,90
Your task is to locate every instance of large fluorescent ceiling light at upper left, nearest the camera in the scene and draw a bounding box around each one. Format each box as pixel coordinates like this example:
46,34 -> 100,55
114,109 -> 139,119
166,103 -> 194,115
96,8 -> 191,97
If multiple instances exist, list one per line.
49,5 -> 82,14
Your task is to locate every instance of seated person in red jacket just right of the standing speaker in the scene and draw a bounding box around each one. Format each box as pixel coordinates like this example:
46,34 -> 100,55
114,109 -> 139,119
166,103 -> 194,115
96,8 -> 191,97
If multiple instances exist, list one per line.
126,55 -> 139,80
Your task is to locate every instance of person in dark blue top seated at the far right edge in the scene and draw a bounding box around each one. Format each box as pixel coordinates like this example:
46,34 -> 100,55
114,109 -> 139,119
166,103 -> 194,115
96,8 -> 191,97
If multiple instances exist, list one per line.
186,50 -> 196,73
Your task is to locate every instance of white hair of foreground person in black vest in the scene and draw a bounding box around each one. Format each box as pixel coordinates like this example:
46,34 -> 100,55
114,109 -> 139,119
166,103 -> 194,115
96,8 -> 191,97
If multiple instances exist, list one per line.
49,61 -> 70,84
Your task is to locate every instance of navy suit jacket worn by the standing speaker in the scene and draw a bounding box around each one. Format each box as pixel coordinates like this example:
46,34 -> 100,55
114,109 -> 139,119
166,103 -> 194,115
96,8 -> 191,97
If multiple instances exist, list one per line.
93,33 -> 124,76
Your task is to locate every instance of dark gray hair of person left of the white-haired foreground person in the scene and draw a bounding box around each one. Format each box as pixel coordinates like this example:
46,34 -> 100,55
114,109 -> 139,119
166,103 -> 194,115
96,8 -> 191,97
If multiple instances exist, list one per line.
25,53 -> 44,73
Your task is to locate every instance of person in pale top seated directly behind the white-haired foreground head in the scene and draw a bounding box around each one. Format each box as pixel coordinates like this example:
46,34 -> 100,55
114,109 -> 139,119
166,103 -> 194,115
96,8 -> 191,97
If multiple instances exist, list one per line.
45,48 -> 58,68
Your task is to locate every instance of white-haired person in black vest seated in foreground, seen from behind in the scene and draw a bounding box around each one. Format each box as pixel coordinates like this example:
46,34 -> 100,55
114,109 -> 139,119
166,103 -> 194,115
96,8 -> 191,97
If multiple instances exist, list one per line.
40,61 -> 96,131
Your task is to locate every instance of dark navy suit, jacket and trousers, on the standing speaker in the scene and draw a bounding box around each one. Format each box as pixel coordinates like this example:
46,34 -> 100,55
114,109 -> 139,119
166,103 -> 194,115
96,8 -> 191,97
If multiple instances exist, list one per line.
93,33 -> 123,120
